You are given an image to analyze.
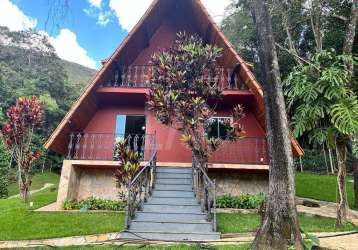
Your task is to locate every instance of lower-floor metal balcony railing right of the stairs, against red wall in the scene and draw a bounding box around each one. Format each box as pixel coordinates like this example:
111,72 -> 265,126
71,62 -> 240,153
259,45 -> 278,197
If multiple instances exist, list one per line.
209,137 -> 269,165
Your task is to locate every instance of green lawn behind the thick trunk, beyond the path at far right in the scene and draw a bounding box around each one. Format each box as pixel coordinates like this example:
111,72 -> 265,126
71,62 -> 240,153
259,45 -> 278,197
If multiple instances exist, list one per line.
296,173 -> 354,208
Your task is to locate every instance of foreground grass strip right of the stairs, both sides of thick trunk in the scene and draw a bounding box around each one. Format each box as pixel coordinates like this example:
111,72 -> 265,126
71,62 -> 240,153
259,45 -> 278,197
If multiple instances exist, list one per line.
217,213 -> 358,233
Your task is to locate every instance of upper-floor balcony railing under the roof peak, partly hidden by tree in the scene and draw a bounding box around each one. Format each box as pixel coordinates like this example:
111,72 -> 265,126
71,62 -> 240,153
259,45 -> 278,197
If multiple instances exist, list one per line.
103,65 -> 247,90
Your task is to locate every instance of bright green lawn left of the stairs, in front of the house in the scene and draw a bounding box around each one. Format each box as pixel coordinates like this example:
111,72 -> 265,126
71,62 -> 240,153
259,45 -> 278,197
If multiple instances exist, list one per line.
0,189 -> 124,240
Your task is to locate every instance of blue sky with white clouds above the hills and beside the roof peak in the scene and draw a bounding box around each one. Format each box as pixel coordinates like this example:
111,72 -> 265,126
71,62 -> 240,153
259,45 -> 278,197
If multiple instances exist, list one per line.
0,0 -> 231,69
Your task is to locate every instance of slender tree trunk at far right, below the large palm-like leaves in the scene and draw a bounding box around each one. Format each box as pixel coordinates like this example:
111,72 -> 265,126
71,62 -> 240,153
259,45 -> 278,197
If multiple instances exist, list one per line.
336,141 -> 348,225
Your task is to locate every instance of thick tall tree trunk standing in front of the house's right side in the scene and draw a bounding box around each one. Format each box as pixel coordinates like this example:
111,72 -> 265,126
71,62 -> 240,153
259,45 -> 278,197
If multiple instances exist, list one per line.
251,0 -> 303,250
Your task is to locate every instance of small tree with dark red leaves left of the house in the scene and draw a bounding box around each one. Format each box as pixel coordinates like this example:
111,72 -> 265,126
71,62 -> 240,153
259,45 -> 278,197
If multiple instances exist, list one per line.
2,96 -> 42,202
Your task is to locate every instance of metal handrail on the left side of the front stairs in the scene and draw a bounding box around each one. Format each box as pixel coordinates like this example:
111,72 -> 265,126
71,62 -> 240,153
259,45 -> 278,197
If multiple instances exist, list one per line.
125,131 -> 157,229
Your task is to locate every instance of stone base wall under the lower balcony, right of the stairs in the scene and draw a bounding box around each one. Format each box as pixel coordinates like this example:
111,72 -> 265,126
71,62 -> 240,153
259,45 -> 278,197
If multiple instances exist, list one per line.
209,171 -> 268,196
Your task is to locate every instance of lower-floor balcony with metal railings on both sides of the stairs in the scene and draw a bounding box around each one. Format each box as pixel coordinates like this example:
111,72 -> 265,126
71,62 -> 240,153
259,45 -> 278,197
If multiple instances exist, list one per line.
67,133 -> 268,165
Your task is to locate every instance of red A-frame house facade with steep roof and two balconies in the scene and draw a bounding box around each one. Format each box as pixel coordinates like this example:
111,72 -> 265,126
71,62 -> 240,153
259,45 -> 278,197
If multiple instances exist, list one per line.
45,0 -> 303,208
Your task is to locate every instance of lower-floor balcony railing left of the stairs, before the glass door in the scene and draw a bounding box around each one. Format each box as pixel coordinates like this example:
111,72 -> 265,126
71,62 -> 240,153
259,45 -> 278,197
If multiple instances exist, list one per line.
67,133 -> 155,161
